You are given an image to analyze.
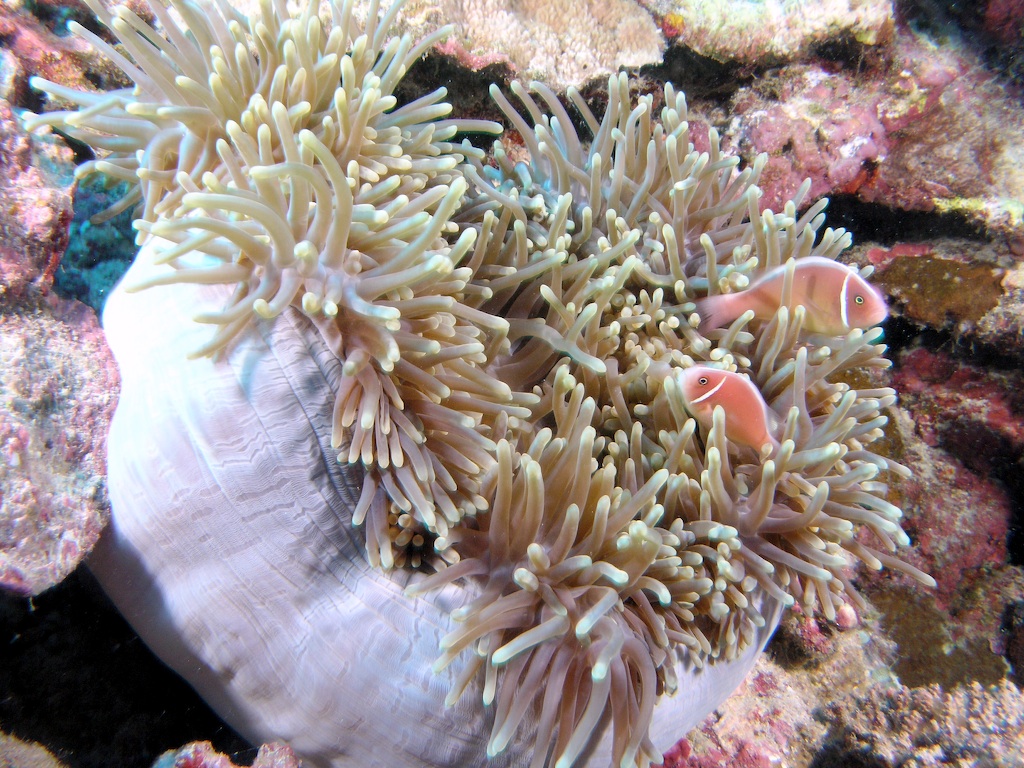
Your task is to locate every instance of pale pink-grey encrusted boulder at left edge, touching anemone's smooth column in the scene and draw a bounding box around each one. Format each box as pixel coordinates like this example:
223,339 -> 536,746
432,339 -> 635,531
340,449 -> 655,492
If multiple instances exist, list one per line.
0,299 -> 118,595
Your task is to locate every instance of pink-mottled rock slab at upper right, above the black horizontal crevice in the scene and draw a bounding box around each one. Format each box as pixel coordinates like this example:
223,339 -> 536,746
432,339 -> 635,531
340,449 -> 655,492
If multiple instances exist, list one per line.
729,28 -> 1024,230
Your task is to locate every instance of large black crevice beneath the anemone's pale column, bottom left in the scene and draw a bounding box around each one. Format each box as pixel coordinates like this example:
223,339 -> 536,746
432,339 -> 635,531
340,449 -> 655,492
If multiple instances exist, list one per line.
0,567 -> 247,768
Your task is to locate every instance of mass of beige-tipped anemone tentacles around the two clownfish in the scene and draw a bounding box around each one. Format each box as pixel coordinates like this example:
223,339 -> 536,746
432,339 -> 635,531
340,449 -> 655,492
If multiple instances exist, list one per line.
28,0 -> 931,766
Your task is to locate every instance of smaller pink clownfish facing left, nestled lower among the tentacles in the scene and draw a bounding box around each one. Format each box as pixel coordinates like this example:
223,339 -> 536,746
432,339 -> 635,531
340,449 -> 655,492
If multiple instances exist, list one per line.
679,366 -> 778,451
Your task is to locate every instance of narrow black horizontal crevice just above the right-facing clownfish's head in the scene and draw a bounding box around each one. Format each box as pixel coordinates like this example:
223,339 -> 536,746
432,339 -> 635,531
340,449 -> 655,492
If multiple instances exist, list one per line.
825,196 -> 987,247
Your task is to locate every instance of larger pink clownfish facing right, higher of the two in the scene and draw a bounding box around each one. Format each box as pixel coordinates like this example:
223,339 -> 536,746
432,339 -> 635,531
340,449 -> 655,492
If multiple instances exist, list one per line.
697,256 -> 888,336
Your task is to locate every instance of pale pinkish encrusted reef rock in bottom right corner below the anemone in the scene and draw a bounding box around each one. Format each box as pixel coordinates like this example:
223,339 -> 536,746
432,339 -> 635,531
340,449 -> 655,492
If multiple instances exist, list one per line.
651,633 -> 1024,768
